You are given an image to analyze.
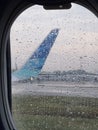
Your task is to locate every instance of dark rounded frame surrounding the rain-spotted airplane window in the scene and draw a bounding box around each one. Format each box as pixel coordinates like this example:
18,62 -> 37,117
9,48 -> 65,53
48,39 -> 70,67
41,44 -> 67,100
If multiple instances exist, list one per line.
0,0 -> 98,130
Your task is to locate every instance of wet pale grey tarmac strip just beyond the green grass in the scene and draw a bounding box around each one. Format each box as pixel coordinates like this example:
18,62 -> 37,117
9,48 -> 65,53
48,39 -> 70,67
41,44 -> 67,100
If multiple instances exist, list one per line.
12,82 -> 98,98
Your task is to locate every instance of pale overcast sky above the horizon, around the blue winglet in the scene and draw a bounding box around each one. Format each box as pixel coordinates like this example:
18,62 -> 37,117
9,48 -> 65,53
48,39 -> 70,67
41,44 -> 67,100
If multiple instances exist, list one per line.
11,4 -> 98,73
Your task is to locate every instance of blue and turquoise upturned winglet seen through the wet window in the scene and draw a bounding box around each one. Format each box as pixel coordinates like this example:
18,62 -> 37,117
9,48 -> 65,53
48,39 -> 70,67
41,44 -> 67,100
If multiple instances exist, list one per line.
12,28 -> 59,81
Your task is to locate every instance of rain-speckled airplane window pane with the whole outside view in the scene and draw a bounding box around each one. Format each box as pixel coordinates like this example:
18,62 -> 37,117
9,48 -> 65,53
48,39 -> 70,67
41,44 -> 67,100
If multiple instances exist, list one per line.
10,4 -> 98,130
